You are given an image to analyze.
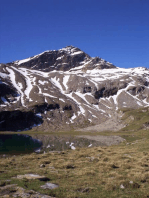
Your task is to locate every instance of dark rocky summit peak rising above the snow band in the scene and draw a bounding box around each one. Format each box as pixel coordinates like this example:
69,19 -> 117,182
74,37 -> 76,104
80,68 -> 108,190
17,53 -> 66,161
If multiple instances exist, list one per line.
11,45 -> 115,72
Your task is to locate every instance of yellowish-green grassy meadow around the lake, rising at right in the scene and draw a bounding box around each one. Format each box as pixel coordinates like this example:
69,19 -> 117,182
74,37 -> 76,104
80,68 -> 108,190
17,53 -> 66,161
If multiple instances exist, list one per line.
0,108 -> 149,198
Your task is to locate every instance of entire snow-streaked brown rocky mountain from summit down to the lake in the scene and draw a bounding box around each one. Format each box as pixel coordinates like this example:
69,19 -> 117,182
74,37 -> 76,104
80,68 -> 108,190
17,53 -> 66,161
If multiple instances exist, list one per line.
0,46 -> 149,131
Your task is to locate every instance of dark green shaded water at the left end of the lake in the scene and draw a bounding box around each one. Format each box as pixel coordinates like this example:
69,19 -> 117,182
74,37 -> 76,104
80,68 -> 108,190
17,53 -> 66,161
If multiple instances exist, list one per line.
0,134 -> 42,155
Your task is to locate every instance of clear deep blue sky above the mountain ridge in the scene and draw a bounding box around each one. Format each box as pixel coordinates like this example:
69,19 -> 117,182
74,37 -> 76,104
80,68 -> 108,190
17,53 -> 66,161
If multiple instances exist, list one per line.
0,0 -> 149,68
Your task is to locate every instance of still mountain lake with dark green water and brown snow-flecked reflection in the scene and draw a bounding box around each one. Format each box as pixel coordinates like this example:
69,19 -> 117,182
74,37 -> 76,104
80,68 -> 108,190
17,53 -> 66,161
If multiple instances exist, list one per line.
0,133 -> 105,157
